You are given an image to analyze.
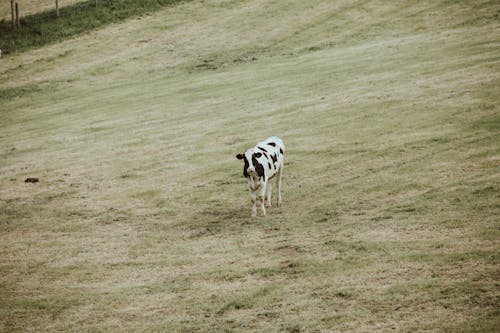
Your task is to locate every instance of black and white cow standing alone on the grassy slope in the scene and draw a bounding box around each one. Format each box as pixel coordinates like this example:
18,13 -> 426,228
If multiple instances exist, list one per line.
236,136 -> 285,217
